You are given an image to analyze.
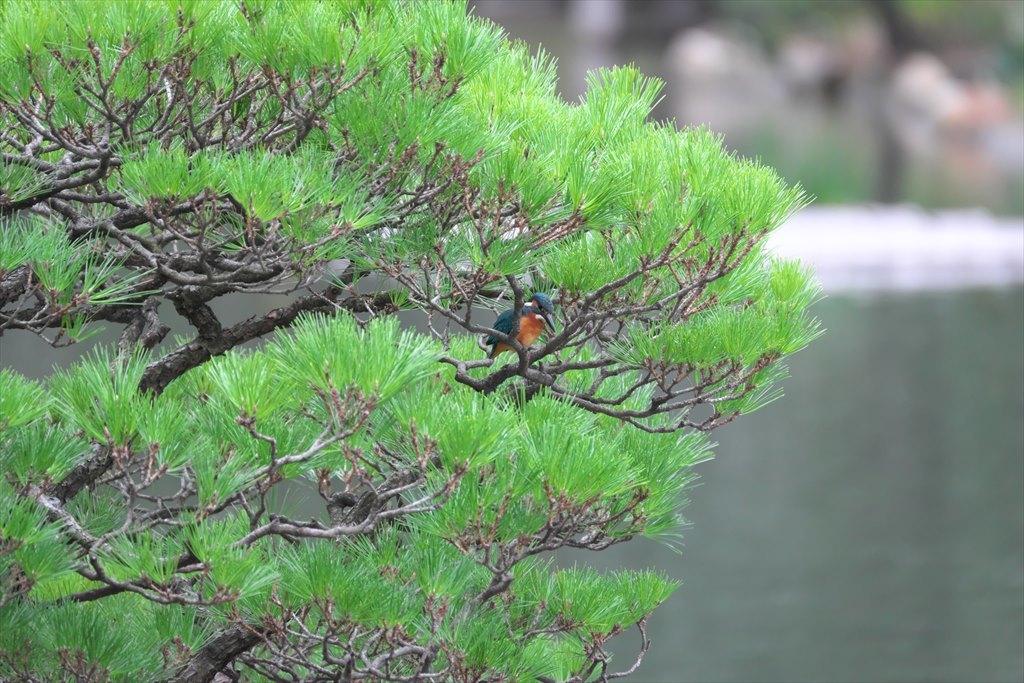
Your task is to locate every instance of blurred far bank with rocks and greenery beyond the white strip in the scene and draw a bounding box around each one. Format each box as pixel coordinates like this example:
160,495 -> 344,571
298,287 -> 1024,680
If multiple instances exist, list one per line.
471,0 -> 1024,214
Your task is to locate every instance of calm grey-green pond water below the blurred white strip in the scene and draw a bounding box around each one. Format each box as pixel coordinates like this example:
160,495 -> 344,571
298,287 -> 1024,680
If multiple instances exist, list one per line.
577,289 -> 1024,682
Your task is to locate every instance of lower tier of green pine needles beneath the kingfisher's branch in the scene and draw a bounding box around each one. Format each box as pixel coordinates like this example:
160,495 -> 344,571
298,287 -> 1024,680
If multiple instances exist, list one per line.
2,317 -> 707,675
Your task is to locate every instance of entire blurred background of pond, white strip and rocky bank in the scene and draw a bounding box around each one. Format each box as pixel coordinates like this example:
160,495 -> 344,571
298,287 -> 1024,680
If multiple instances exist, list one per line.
473,0 -> 1024,682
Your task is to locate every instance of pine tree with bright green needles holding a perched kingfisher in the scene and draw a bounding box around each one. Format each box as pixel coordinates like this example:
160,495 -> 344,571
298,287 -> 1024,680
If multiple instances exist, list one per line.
0,0 -> 818,681
